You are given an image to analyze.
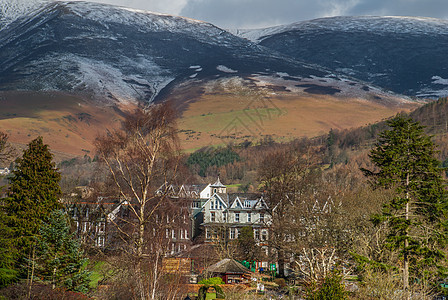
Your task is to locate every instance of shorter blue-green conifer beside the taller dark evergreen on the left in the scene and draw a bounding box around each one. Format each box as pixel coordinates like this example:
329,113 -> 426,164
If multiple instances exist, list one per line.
36,210 -> 90,292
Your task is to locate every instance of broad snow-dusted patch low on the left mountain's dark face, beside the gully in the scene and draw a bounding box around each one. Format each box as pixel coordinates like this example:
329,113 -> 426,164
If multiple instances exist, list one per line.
25,54 -> 175,103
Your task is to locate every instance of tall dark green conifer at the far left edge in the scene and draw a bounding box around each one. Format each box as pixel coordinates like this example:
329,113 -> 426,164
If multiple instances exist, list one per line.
2,137 -> 61,271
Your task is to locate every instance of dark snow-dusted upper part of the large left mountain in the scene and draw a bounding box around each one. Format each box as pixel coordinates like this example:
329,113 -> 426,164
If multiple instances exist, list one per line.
0,1 -> 334,102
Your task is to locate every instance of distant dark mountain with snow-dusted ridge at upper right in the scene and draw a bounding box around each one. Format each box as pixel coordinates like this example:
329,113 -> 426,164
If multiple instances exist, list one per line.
235,17 -> 448,97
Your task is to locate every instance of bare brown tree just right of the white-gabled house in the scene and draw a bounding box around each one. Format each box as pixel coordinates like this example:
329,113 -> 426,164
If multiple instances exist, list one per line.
259,144 -> 320,277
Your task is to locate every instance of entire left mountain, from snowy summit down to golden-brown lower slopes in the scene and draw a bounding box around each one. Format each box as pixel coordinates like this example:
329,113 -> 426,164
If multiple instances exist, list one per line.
0,1 -> 428,155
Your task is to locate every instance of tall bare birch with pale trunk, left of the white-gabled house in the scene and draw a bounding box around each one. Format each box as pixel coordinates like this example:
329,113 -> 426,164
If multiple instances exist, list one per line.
96,103 -> 179,299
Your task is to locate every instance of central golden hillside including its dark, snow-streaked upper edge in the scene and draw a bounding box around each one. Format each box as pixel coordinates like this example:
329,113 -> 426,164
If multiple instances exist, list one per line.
167,76 -> 421,151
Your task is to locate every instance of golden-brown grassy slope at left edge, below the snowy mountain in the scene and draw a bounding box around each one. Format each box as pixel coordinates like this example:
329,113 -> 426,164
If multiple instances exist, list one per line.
0,92 -> 131,156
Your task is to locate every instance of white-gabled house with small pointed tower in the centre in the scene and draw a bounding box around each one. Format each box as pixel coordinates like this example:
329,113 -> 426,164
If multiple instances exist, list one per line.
159,178 -> 271,252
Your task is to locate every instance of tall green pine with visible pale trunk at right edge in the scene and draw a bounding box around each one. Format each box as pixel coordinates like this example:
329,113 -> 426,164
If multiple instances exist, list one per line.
363,115 -> 447,298
